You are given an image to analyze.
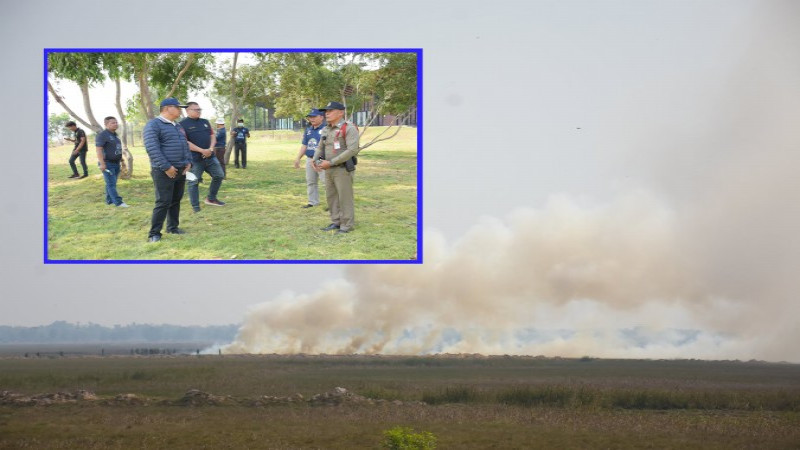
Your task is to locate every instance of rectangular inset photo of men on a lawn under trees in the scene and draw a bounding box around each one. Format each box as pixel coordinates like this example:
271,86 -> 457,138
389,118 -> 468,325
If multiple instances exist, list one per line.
44,49 -> 422,263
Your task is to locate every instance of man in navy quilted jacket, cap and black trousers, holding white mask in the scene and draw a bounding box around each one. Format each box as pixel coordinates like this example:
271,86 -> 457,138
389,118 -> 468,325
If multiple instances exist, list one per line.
143,98 -> 192,242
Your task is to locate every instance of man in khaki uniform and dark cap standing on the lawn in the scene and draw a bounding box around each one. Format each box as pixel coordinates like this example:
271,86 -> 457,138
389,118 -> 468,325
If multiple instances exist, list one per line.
313,102 -> 359,234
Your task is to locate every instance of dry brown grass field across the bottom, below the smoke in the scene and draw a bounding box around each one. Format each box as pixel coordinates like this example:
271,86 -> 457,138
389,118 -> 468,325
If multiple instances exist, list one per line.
0,355 -> 800,449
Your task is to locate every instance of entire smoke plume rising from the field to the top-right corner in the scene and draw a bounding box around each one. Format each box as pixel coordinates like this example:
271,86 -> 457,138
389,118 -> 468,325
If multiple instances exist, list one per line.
226,2 -> 800,362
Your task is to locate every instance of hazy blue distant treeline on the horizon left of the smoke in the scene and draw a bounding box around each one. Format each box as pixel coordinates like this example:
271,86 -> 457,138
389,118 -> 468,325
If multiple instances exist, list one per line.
0,321 -> 239,343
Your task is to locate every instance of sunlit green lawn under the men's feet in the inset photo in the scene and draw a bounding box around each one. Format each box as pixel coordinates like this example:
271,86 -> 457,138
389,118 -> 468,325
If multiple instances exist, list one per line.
47,127 -> 418,261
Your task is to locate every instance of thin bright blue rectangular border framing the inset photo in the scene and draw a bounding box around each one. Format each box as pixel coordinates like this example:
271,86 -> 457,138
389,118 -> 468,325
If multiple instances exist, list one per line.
42,48 -> 424,264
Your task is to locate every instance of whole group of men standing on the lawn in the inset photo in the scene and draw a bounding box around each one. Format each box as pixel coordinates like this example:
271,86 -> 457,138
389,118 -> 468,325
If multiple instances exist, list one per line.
67,98 -> 359,242
